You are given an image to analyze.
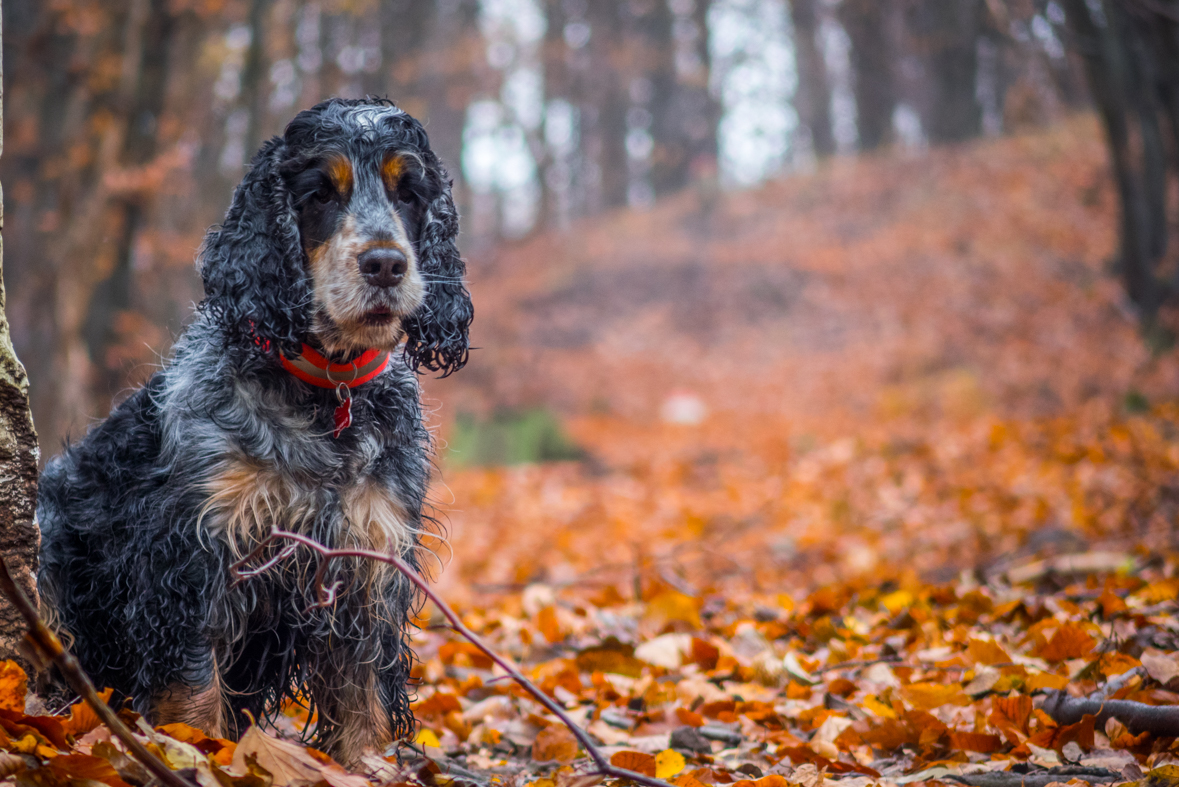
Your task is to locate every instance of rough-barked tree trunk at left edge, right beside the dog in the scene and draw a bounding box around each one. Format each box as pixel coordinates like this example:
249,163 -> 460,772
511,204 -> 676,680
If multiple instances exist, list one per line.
0,0 -> 41,674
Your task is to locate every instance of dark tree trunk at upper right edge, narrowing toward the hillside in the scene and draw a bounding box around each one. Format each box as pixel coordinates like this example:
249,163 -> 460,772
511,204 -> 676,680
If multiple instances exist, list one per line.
1065,0 -> 1179,328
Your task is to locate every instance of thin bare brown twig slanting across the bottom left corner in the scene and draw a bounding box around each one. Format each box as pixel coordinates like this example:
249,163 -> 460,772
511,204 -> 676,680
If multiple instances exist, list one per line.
0,560 -> 193,787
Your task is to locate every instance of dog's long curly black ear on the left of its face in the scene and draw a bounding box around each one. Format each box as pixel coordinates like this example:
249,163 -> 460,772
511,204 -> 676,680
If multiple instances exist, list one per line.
198,137 -> 311,356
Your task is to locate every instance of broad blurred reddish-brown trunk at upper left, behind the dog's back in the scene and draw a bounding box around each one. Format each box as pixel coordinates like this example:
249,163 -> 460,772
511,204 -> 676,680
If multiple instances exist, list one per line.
5,0 -> 150,443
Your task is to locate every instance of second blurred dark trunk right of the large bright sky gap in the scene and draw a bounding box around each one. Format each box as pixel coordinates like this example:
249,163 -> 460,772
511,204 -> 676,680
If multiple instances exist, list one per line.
838,0 -> 896,151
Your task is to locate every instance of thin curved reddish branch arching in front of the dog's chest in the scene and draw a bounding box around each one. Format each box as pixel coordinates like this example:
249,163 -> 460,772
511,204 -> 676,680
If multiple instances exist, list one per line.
230,530 -> 672,787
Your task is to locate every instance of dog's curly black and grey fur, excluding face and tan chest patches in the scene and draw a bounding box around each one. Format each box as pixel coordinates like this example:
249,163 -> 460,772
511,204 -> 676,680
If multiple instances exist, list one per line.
38,99 -> 472,758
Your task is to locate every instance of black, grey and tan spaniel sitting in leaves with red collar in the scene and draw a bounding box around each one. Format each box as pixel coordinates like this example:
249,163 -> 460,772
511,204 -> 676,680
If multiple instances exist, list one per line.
37,99 -> 474,765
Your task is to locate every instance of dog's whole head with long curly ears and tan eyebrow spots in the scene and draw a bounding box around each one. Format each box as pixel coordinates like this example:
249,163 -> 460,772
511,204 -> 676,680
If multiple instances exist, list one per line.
200,99 -> 473,375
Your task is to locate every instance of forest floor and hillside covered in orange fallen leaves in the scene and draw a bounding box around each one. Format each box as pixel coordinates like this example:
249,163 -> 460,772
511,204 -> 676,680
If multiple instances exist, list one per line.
0,118 -> 1179,787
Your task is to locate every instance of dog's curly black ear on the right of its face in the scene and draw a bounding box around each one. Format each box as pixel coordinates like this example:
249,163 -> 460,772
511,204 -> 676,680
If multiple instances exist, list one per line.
406,161 -> 475,377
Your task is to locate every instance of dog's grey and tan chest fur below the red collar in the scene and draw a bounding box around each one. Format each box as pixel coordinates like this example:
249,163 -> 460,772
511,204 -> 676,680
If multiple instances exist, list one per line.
164,322 -> 427,557
